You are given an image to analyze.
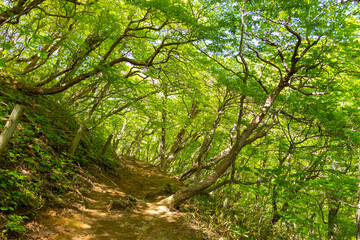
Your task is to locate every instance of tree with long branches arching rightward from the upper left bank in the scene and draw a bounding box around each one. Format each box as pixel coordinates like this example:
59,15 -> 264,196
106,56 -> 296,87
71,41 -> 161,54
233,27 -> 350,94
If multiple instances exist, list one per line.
1,0 -> 200,94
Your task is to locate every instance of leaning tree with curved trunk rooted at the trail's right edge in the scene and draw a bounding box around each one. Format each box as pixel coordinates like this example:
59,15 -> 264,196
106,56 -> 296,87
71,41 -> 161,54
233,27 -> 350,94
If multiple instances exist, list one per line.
161,1 -> 353,207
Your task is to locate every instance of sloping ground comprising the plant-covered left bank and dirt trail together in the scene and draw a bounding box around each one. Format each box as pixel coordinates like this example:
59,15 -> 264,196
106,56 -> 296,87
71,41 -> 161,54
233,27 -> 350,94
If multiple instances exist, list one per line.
0,83 -> 219,240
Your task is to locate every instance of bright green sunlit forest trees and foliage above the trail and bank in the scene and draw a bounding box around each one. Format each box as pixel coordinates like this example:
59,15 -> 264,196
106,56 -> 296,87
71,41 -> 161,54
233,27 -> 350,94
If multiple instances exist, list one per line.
0,0 -> 360,239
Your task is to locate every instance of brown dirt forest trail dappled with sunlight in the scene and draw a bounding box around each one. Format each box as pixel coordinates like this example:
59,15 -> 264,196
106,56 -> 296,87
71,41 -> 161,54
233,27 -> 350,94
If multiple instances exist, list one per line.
24,159 -> 204,240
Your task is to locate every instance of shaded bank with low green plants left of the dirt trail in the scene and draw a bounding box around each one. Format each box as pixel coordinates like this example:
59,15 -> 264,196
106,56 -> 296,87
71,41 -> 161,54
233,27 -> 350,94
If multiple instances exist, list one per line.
0,84 -> 114,239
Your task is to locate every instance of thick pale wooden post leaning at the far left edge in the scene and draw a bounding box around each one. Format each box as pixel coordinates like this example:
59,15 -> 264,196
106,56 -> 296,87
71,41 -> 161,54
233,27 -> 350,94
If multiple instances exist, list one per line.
0,104 -> 25,157
